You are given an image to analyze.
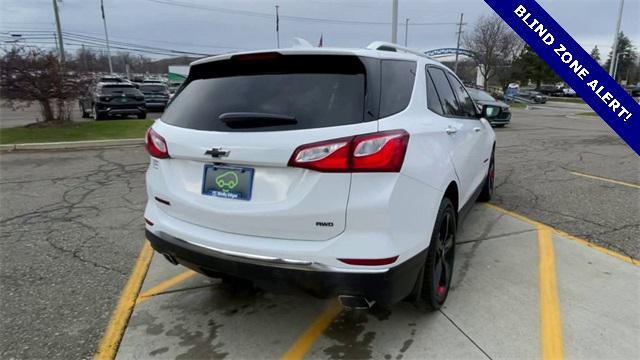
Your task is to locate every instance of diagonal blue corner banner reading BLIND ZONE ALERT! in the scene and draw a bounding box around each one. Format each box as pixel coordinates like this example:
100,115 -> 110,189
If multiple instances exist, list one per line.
485,0 -> 640,155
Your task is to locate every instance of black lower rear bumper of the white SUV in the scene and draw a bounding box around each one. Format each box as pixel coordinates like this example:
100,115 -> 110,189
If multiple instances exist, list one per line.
146,230 -> 426,304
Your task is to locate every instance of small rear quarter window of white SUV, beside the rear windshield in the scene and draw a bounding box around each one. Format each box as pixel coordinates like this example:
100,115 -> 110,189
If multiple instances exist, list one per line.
380,60 -> 416,118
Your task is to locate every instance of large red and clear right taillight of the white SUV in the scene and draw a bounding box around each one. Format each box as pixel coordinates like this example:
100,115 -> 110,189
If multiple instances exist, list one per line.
289,130 -> 409,172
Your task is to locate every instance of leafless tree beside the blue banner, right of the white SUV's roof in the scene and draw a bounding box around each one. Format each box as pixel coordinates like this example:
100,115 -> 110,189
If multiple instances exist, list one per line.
463,15 -> 524,89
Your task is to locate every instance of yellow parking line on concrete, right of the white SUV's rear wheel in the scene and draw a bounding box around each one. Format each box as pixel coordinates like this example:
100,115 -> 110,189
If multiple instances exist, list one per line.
538,226 -> 564,360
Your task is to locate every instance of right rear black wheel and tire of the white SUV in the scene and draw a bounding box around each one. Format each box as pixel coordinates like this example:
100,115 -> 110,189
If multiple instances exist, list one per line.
416,198 -> 457,311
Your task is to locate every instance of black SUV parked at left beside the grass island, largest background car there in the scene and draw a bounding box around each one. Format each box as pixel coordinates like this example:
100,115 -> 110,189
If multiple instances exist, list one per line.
79,82 -> 147,120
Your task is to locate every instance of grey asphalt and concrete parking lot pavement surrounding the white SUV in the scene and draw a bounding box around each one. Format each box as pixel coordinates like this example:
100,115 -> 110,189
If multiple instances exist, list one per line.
0,104 -> 640,359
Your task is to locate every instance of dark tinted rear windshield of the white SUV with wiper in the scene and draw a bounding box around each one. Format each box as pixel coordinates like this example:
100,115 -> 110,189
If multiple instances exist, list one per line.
162,53 -> 366,131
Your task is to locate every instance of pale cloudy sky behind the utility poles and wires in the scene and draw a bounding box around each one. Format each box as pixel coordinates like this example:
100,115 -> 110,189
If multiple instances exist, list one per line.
0,0 -> 640,58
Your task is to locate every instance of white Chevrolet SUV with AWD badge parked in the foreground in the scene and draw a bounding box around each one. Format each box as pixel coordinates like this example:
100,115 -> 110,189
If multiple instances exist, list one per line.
145,43 -> 500,309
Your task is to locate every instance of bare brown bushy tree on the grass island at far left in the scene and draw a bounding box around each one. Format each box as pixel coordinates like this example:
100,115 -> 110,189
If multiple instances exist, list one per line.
0,47 -> 90,123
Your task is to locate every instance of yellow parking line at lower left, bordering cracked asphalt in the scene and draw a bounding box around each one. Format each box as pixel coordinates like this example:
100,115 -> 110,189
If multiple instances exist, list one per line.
95,240 -> 153,360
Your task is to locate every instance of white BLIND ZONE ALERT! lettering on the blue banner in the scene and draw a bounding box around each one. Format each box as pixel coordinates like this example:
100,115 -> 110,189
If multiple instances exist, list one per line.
514,5 -> 633,121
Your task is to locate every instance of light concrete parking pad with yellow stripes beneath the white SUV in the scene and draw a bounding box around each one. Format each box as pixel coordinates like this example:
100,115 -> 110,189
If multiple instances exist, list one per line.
100,205 -> 640,359
